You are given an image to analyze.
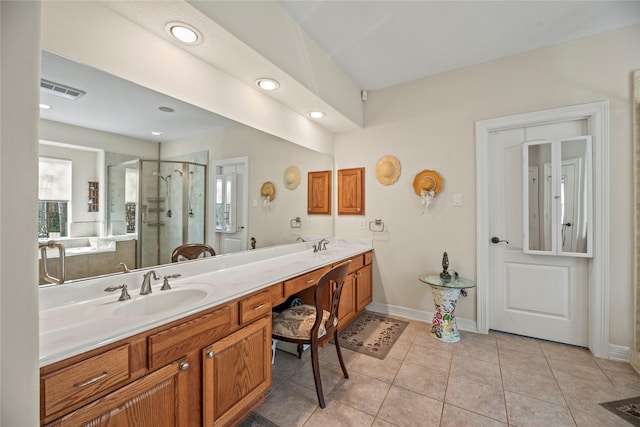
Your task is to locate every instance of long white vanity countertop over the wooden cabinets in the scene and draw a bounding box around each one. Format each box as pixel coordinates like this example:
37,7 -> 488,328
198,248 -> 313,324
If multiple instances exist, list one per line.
40,238 -> 372,367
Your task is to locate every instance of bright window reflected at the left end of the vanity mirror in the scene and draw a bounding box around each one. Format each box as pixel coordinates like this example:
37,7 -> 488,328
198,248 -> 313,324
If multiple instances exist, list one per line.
38,157 -> 71,238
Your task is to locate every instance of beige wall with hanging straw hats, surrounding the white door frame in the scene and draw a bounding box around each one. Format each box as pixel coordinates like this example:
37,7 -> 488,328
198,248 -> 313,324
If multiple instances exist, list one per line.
335,26 -> 640,347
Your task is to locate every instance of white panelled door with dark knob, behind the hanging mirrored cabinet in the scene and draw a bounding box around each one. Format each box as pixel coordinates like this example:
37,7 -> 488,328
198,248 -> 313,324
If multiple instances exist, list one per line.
487,120 -> 589,346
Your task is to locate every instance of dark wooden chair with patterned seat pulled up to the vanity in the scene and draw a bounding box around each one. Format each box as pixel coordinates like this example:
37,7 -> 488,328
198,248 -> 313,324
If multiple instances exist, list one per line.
272,261 -> 351,408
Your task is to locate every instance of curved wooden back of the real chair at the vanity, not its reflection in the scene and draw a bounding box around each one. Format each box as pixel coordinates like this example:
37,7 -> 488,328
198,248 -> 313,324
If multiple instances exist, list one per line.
311,260 -> 351,341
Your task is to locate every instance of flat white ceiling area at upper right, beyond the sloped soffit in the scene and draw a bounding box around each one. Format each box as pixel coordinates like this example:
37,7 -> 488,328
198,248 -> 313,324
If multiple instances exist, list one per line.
278,0 -> 640,90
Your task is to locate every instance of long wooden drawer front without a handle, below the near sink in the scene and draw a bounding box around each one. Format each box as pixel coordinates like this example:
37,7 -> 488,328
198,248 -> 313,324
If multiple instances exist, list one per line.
148,306 -> 232,369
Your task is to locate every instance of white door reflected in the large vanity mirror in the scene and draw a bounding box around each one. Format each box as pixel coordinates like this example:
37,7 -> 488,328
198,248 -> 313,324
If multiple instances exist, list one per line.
213,157 -> 248,254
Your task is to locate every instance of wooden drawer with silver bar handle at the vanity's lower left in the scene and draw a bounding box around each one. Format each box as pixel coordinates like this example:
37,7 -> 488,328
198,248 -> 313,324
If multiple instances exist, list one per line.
41,344 -> 130,416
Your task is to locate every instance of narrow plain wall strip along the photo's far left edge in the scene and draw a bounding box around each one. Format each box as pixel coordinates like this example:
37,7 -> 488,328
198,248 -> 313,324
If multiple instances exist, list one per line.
0,1 -> 40,426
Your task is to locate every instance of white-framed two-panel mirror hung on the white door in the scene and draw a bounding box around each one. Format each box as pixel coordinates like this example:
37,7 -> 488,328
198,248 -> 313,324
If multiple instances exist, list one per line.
523,136 -> 593,257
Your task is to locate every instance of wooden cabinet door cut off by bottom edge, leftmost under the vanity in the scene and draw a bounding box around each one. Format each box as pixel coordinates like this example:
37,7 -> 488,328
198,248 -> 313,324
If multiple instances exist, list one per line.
48,361 -> 189,427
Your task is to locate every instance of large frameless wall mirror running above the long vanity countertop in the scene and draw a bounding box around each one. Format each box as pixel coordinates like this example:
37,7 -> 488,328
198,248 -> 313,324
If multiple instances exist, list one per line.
38,52 -> 333,284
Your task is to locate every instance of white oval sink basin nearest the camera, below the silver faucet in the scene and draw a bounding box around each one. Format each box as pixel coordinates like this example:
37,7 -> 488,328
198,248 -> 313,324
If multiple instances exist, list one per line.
113,288 -> 209,317
